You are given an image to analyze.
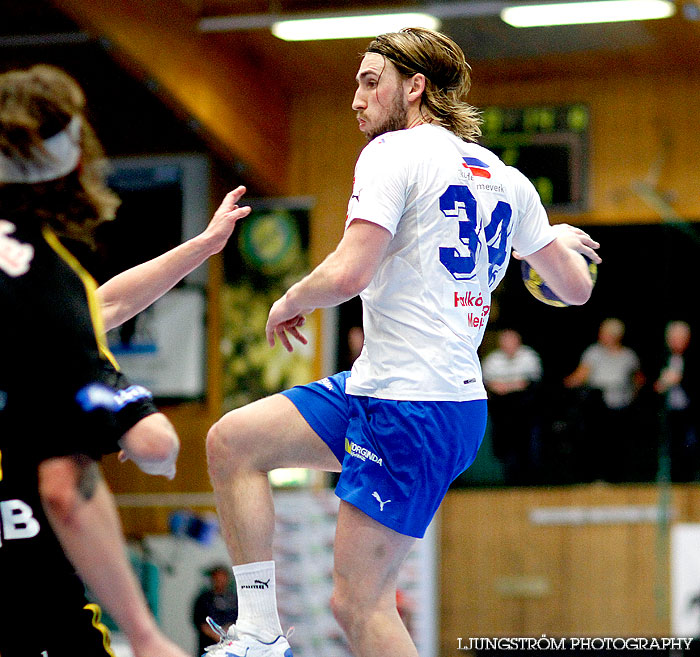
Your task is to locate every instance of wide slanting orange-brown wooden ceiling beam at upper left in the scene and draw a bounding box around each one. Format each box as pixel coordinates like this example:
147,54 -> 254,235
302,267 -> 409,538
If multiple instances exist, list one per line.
51,0 -> 290,194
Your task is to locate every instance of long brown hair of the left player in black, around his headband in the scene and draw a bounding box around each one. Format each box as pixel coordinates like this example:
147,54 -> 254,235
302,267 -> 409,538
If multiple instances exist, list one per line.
0,64 -> 119,244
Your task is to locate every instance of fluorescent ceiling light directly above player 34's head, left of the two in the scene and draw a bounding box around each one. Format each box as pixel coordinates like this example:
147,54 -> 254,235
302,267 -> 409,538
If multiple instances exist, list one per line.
272,13 -> 440,41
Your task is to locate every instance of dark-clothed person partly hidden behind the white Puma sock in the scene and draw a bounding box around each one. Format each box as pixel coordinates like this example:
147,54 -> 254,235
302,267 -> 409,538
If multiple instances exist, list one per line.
192,564 -> 238,655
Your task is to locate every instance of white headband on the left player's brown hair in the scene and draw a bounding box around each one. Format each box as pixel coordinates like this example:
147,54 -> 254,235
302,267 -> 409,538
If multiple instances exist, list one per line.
0,116 -> 81,184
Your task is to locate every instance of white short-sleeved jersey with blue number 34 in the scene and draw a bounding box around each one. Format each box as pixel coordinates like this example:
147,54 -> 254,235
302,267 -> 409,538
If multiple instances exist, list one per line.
346,125 -> 555,401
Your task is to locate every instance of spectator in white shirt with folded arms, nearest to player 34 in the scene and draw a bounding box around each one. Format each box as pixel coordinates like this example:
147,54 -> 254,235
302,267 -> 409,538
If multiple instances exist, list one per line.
483,329 -> 542,484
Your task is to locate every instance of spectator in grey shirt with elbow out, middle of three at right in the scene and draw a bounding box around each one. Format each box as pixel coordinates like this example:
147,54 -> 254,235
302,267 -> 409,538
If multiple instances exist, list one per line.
564,318 -> 645,482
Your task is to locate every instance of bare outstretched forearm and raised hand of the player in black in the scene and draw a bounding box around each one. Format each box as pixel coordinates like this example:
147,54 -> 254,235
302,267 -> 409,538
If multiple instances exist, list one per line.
97,186 -> 250,330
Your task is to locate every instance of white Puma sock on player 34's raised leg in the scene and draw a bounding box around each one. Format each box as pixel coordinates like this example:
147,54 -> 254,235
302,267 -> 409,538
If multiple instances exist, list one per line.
233,561 -> 283,641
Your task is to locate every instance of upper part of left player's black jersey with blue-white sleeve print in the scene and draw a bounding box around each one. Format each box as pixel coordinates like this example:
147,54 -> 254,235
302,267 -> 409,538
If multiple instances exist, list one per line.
0,219 -> 156,460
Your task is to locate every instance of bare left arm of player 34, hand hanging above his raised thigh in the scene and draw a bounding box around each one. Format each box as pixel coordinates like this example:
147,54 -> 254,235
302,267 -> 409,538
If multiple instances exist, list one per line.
265,219 -> 392,351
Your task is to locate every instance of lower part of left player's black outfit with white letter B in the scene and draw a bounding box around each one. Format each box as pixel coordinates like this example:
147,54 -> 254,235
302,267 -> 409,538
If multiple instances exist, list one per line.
0,418 -> 114,657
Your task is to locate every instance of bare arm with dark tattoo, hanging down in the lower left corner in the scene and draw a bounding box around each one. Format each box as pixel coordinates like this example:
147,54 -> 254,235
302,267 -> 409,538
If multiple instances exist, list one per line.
39,457 -> 190,657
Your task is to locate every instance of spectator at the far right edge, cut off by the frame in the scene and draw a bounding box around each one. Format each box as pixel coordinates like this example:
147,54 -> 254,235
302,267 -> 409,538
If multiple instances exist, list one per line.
654,321 -> 698,481
